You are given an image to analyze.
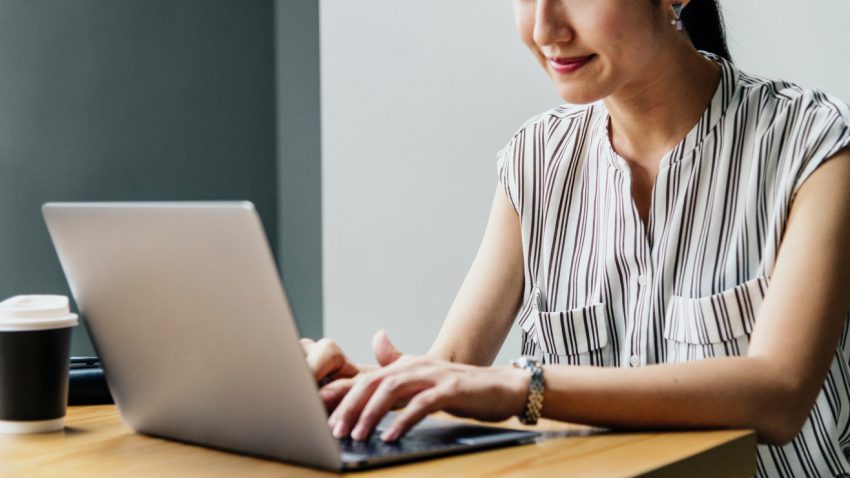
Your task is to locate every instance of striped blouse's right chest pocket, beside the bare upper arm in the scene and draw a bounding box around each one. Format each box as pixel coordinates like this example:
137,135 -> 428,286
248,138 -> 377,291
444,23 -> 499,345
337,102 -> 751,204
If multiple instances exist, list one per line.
664,277 -> 768,363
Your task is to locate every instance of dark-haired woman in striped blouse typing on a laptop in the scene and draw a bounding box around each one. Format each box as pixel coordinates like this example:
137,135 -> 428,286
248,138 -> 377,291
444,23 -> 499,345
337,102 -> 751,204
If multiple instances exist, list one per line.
303,0 -> 850,476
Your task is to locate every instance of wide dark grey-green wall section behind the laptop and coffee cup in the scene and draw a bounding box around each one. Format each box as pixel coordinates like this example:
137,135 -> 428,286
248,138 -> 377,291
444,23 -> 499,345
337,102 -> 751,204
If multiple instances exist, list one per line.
0,0 -> 286,354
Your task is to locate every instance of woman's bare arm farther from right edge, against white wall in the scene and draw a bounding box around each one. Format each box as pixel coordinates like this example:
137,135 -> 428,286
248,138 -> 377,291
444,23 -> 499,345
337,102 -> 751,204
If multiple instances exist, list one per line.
429,184 -> 523,365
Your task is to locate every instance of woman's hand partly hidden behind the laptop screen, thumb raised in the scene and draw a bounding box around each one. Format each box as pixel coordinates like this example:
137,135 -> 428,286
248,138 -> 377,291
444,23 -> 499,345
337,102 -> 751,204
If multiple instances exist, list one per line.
300,330 -> 401,411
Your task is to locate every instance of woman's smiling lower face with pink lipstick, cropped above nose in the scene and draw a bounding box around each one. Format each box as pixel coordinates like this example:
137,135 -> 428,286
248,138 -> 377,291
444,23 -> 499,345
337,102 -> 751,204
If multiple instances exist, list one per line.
514,0 -> 686,104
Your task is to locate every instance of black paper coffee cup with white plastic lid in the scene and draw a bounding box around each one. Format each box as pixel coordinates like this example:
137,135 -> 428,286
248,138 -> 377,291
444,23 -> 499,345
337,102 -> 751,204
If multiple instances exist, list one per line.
0,295 -> 77,434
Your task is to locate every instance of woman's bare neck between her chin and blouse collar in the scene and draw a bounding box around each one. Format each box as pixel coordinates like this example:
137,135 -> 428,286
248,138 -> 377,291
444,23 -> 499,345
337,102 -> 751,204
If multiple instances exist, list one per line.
605,45 -> 720,169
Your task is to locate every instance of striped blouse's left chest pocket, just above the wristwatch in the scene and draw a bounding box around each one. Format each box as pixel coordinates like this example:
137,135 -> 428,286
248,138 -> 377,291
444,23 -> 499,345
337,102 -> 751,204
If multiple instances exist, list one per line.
533,303 -> 612,366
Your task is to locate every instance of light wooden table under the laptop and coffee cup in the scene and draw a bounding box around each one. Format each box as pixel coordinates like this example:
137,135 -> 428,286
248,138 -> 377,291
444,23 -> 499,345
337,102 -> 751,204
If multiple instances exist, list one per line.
0,405 -> 756,478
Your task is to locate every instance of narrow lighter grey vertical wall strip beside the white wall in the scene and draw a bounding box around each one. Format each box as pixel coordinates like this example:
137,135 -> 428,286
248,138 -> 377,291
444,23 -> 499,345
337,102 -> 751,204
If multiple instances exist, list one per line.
275,0 -> 322,338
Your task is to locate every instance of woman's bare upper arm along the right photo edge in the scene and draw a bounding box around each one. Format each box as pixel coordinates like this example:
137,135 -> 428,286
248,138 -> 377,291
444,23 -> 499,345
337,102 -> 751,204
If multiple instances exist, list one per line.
748,148 -> 850,423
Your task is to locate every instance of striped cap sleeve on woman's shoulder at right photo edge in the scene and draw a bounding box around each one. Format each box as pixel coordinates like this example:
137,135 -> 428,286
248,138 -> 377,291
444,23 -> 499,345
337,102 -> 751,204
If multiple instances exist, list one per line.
792,92 -> 850,198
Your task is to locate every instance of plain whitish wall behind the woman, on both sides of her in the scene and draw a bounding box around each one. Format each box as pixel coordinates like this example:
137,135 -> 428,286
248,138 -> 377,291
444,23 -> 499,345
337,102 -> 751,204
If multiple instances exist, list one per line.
320,0 -> 850,363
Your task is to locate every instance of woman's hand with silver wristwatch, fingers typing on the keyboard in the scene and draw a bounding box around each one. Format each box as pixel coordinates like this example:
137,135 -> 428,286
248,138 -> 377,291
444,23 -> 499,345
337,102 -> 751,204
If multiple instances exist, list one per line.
328,333 -> 529,441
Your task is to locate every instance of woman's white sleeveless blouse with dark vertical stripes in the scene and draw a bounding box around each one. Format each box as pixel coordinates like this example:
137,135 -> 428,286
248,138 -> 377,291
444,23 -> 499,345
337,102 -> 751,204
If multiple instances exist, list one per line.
498,53 -> 850,476
